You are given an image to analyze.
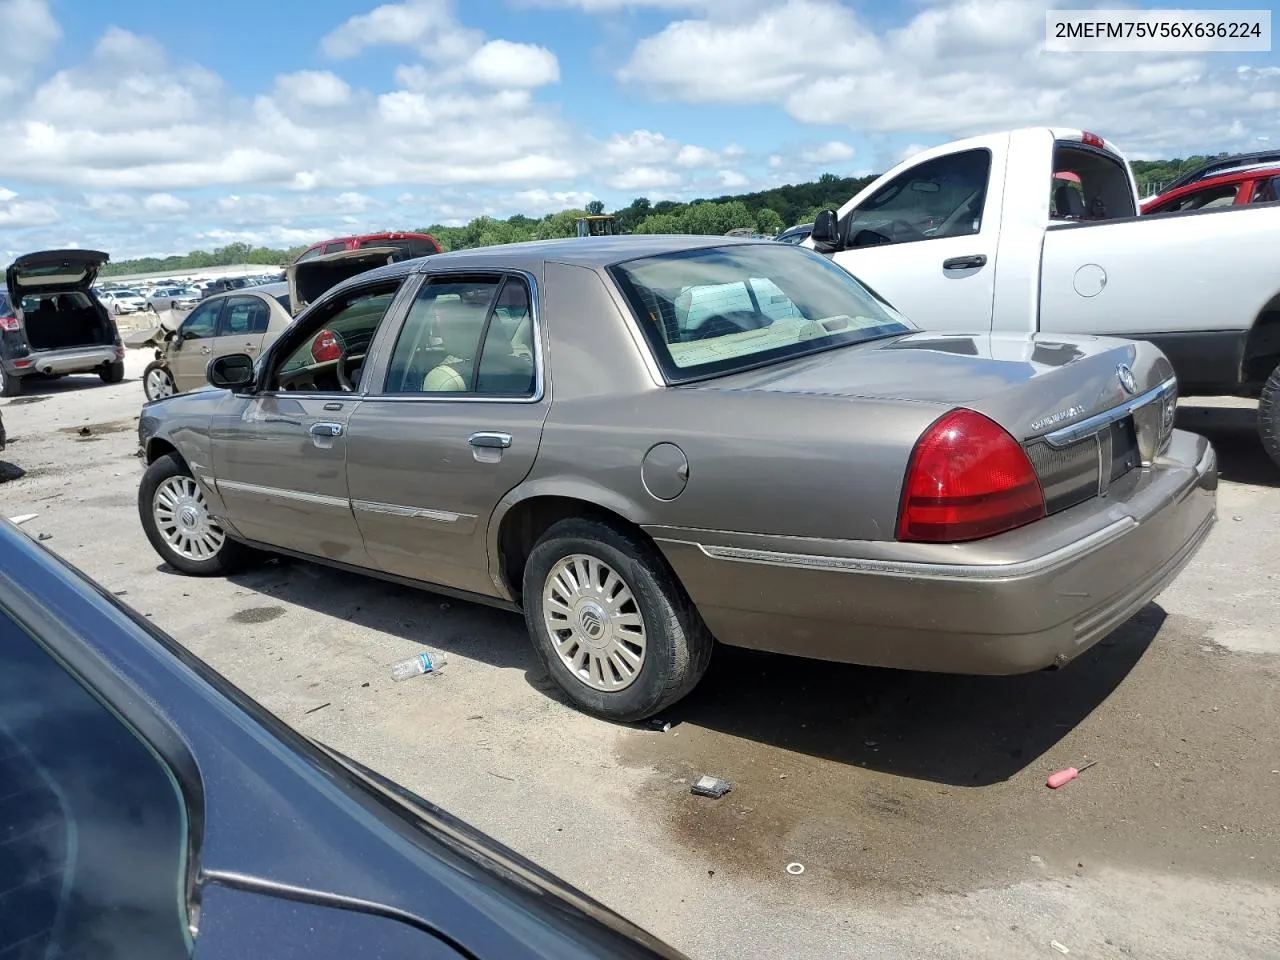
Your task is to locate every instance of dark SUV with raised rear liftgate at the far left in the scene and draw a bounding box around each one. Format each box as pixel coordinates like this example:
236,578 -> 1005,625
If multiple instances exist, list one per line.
0,250 -> 124,397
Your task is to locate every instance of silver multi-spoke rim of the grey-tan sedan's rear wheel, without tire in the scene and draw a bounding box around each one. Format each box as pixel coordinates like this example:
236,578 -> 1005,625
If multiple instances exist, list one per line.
543,553 -> 645,692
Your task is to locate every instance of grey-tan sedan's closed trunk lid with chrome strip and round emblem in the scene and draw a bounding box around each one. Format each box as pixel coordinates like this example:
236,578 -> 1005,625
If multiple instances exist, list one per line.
696,333 -> 1178,522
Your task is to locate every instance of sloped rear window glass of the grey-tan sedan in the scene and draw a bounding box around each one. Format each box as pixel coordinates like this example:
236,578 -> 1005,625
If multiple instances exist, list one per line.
611,243 -> 915,381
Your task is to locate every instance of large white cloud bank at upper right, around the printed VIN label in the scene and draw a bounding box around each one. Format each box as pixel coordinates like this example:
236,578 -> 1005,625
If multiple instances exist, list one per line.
618,0 -> 1280,157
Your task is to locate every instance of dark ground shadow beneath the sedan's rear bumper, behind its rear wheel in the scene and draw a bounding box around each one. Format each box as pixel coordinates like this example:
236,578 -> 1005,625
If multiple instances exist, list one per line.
663,603 -> 1165,787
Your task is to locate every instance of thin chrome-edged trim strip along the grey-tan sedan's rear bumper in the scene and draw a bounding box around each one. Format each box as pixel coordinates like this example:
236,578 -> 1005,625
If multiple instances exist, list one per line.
659,517 -> 1138,580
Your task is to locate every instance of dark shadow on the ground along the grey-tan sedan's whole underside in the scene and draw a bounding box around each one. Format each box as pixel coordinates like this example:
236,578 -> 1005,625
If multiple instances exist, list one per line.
180,558 -> 1165,786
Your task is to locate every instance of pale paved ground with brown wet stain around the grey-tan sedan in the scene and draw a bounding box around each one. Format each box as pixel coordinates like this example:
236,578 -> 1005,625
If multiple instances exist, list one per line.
0,355 -> 1280,959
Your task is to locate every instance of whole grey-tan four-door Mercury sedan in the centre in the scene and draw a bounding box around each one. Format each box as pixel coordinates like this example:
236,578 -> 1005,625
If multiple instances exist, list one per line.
138,236 -> 1217,721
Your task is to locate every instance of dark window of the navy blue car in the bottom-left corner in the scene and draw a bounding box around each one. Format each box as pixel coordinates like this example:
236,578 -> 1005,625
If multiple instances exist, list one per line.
0,611 -> 192,960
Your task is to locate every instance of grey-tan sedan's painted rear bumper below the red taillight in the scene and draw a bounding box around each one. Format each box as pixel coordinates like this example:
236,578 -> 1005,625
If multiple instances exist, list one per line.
650,431 -> 1217,675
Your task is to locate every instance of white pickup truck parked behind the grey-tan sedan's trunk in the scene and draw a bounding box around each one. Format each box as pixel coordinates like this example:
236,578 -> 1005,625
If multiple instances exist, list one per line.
805,127 -> 1280,463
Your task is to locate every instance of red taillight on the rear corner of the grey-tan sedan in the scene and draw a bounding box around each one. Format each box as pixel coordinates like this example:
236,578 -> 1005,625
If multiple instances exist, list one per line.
897,410 -> 1044,543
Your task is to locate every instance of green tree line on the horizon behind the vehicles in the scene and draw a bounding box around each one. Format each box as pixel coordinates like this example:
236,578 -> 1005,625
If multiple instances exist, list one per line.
102,154 -> 1226,276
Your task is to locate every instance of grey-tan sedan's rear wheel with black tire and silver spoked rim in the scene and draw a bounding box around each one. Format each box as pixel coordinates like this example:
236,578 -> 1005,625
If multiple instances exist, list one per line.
524,518 -> 714,722
